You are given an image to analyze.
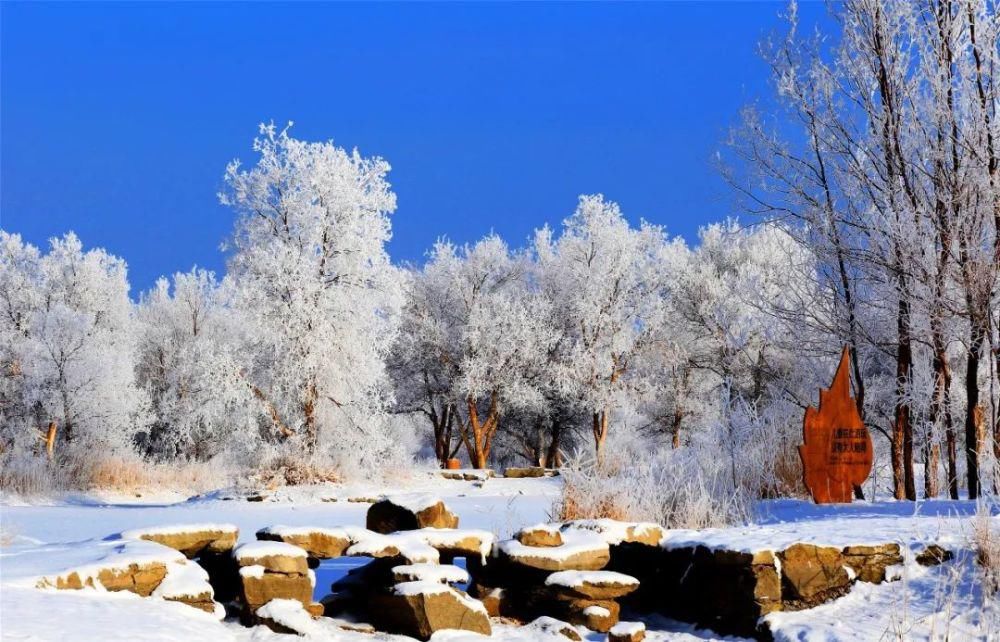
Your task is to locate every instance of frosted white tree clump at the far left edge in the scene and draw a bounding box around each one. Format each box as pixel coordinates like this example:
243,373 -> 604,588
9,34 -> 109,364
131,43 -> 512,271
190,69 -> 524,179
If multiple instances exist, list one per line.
0,231 -> 148,454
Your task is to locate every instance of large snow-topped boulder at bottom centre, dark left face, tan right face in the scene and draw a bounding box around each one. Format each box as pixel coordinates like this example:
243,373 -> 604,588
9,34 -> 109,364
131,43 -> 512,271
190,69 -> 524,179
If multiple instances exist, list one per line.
371,582 -> 491,640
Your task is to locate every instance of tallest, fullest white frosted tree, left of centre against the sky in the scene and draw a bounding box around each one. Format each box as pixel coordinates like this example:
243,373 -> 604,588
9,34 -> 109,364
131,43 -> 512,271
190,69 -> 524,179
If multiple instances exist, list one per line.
221,125 -> 402,469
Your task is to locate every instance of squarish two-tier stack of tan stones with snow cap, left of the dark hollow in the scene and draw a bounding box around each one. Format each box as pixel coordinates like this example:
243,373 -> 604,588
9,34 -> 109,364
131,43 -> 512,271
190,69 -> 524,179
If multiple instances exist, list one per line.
233,541 -> 323,623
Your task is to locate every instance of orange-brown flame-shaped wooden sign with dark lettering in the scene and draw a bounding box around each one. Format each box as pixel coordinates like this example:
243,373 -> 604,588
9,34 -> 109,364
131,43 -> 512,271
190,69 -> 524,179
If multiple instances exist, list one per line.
799,347 -> 872,504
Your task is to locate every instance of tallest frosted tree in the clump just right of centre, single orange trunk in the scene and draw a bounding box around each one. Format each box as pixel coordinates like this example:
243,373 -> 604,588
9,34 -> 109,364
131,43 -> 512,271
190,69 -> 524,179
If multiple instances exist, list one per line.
535,194 -> 670,454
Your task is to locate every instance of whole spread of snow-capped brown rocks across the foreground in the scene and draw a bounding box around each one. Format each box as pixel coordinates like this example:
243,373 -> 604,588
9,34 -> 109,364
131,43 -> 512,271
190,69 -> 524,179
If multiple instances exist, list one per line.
37,495 -> 936,642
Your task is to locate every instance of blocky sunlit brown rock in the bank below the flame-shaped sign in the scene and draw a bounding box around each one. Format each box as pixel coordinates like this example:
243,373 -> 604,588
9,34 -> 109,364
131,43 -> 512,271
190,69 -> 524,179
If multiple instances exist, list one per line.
778,544 -> 852,608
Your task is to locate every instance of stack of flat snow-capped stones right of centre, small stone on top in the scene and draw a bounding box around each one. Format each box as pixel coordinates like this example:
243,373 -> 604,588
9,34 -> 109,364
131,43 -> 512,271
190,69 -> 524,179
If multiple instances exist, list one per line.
473,524 -> 639,633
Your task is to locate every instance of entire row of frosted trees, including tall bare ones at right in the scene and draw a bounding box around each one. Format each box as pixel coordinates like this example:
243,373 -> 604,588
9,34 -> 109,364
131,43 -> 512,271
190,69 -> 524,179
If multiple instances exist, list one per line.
0,0 -> 1000,499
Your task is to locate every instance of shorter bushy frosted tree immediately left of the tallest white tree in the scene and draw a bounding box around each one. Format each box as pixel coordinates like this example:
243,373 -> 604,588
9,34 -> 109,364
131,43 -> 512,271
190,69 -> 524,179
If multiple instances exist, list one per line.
136,269 -> 260,459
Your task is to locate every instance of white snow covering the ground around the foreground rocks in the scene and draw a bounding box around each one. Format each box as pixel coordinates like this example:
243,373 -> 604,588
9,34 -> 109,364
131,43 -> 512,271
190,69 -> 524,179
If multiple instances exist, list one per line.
0,474 -> 1000,642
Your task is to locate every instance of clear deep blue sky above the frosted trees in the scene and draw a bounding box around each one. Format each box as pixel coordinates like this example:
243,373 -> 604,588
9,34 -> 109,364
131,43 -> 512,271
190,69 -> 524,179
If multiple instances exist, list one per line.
0,2 -> 826,295
